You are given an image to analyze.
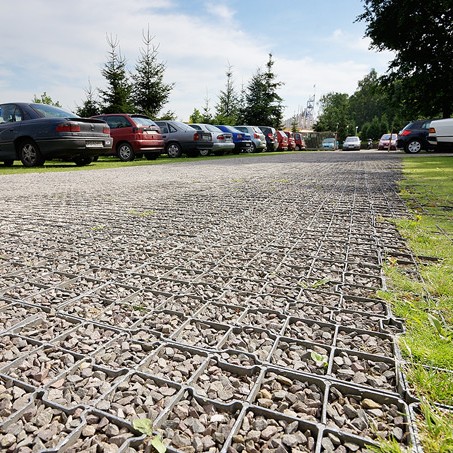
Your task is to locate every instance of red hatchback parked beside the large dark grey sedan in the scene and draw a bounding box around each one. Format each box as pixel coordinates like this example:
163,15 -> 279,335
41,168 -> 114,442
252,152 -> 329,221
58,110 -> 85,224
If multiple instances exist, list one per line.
92,113 -> 164,162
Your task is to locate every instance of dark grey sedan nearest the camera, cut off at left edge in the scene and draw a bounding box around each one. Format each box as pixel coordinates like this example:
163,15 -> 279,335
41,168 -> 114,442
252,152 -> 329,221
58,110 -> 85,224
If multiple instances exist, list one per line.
0,102 -> 113,167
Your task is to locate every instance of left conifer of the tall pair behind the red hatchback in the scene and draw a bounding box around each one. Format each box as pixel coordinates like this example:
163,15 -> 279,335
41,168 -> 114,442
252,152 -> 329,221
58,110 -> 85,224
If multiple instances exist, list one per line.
99,37 -> 134,113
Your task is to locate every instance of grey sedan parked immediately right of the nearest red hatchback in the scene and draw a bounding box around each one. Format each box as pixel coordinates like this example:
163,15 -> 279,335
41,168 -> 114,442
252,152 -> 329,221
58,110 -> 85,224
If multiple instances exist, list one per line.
156,121 -> 214,157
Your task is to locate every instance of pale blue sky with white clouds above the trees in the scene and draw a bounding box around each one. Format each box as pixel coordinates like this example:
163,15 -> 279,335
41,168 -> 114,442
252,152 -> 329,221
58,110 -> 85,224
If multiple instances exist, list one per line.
0,0 -> 392,121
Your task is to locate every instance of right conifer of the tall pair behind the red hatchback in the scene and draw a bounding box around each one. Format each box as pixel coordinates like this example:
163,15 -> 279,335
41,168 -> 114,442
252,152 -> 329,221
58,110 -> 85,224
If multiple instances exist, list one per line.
131,27 -> 174,118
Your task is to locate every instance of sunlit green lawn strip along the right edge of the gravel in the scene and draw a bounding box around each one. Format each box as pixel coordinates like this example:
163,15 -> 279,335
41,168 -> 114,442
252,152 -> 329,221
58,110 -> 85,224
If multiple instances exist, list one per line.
380,156 -> 453,453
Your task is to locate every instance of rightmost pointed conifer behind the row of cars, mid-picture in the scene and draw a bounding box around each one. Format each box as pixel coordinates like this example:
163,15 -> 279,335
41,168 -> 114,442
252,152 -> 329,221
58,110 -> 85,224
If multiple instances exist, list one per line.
240,54 -> 283,129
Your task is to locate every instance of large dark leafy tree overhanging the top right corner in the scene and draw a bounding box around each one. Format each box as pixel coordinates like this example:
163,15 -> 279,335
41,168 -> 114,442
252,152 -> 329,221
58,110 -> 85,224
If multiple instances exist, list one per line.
357,0 -> 453,117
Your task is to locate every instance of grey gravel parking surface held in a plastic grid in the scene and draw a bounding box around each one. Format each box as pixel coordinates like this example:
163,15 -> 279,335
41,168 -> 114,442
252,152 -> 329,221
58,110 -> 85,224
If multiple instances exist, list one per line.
0,151 -> 415,453
